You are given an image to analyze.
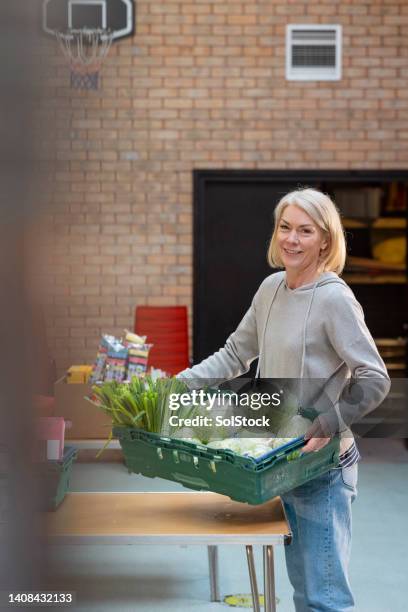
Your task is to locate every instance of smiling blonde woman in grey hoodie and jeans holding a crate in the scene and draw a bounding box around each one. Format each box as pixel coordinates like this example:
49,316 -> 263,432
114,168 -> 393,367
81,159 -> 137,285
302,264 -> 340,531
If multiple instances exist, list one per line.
179,189 -> 390,612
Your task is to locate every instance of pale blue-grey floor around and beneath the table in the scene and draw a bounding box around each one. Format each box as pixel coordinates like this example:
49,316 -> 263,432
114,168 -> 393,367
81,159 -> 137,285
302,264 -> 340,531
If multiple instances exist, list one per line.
51,440 -> 408,612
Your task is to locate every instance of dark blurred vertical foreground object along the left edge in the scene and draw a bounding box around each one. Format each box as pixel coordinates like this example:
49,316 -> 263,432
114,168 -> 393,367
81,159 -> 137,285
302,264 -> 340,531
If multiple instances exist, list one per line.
0,0 -> 50,591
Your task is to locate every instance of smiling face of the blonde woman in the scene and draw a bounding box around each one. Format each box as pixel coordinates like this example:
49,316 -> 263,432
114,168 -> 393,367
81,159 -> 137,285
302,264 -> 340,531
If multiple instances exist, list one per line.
277,204 -> 327,272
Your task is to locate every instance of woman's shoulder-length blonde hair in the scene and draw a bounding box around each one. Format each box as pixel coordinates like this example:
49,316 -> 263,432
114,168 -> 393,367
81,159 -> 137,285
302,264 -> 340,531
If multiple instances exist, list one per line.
268,188 -> 346,274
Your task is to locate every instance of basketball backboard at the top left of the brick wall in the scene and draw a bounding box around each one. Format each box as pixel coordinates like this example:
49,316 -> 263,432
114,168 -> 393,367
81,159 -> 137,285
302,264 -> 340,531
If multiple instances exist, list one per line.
43,0 -> 134,39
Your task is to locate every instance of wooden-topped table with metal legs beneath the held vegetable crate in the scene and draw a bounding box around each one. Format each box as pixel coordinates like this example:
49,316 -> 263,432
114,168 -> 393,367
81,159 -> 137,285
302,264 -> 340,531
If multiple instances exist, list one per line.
47,492 -> 291,612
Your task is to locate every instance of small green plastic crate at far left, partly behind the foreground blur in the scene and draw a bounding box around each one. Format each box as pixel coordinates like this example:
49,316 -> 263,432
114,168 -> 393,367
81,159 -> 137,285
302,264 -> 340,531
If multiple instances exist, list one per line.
41,446 -> 78,510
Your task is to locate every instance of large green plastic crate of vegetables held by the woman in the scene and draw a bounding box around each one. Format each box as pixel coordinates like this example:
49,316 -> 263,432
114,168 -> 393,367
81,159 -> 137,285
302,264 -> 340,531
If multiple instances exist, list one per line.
113,427 -> 339,505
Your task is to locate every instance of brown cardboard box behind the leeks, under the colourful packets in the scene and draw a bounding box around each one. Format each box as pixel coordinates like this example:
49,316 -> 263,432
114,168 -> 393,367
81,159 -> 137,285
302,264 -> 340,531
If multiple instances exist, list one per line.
54,376 -> 112,440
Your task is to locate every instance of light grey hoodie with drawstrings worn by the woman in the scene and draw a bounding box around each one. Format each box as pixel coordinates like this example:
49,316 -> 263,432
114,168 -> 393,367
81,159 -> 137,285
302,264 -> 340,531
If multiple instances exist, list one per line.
179,272 -> 390,448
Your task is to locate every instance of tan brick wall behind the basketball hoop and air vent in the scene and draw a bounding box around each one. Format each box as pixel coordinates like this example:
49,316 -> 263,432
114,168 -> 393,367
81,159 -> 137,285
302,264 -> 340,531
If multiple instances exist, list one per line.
32,0 -> 408,370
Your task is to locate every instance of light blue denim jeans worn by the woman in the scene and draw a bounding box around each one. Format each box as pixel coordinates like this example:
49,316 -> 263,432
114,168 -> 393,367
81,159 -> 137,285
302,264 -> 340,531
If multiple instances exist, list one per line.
282,464 -> 358,612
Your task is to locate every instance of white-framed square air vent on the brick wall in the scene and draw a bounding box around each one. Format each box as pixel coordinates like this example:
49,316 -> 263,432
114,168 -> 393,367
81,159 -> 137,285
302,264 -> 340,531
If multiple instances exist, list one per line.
286,24 -> 341,81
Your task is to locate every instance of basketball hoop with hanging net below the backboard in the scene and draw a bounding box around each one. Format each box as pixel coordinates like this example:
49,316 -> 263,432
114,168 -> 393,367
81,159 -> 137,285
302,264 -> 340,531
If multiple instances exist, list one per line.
55,28 -> 114,89
